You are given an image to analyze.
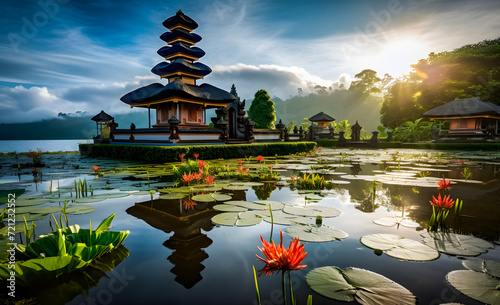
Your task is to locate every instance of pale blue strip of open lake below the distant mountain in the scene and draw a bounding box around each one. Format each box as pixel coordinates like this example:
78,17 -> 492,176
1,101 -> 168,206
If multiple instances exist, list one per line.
0,139 -> 92,153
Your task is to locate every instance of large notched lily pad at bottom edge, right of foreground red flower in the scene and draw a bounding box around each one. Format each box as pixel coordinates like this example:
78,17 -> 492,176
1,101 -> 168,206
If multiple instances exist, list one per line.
306,266 -> 417,305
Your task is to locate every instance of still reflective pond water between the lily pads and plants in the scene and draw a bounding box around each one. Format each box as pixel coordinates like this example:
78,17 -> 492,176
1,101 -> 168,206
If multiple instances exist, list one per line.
0,149 -> 500,304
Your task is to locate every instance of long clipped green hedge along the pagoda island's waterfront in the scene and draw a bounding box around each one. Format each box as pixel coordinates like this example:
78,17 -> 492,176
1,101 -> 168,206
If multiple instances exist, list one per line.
79,142 -> 316,163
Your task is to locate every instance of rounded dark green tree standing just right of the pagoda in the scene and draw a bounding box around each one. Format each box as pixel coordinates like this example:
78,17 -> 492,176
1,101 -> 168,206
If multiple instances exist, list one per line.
248,89 -> 276,128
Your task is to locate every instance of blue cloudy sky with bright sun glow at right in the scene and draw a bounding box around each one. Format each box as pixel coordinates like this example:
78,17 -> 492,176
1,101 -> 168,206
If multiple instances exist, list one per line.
0,0 -> 500,123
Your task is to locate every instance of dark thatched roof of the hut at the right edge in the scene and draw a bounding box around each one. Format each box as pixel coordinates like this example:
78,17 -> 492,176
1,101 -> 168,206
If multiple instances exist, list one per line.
423,97 -> 500,118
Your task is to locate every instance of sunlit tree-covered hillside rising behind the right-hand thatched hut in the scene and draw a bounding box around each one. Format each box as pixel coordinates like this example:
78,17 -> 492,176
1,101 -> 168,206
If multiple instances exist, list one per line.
380,38 -> 500,128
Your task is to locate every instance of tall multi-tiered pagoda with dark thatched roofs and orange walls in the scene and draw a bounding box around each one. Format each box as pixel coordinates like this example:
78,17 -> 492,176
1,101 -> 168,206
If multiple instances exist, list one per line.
121,11 -> 235,128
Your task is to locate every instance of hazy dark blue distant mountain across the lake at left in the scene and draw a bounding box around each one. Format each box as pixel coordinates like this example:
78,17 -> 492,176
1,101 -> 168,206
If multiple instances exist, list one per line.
0,110 -> 155,140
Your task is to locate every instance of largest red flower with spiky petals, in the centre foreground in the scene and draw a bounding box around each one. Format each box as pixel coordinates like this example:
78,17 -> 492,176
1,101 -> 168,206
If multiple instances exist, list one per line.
256,231 -> 307,275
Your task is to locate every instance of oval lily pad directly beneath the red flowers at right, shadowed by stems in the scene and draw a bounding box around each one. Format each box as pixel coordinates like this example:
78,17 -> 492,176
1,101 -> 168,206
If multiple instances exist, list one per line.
421,232 -> 494,256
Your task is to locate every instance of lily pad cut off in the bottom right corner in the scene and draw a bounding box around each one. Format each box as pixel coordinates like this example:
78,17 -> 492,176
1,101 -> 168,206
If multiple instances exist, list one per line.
446,270 -> 500,304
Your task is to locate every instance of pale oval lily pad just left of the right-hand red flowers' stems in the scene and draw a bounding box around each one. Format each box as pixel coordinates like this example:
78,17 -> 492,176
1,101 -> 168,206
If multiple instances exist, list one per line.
360,234 -> 439,261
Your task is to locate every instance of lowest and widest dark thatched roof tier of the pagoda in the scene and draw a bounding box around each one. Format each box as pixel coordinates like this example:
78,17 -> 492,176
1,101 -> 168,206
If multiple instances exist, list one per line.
121,79 -> 236,106
